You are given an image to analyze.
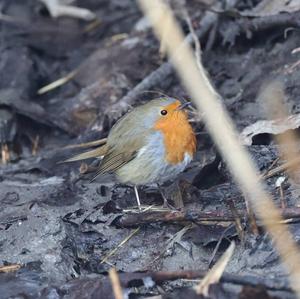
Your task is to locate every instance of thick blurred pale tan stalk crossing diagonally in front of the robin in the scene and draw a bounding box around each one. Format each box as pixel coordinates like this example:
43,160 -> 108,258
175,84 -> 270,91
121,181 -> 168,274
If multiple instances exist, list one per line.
139,0 -> 300,298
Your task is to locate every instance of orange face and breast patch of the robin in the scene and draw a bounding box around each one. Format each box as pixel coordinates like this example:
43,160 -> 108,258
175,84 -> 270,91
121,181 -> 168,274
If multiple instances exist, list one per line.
154,110 -> 196,164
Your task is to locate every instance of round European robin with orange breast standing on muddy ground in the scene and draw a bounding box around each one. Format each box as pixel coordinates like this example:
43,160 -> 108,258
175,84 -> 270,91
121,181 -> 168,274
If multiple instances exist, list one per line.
66,97 -> 196,208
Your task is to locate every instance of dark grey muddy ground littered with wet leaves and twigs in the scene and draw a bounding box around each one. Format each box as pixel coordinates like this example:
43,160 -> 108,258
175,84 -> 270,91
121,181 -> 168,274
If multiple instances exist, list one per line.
0,0 -> 300,298
